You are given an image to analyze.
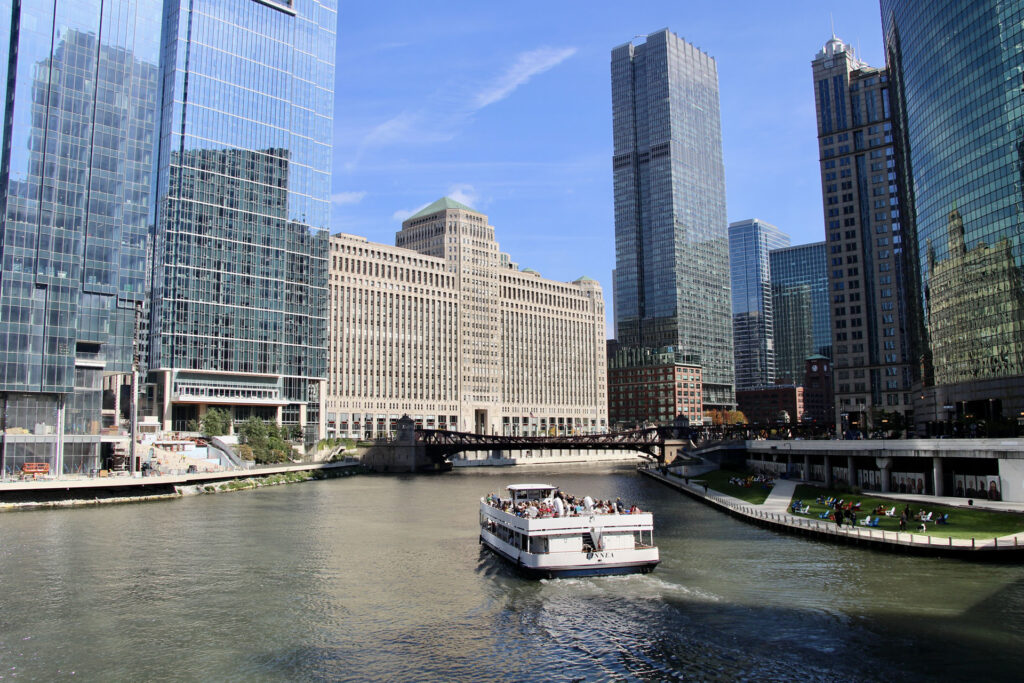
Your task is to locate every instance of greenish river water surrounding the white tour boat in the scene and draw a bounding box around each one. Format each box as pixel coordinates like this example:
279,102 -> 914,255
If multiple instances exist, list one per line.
0,467 -> 1024,682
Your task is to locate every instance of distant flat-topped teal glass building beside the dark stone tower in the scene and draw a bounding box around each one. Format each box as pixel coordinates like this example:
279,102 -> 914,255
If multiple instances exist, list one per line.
768,242 -> 831,387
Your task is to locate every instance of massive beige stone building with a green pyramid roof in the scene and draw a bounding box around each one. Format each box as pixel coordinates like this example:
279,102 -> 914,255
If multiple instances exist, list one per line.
327,198 -> 607,444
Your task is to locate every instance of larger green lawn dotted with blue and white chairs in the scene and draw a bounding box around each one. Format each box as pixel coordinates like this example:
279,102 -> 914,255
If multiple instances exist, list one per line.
786,485 -> 1024,540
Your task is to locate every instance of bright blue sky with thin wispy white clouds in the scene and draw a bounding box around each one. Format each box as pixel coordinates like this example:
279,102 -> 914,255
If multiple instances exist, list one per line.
331,0 -> 884,332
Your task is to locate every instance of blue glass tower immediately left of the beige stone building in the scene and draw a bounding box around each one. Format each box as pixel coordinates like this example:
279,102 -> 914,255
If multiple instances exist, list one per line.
150,0 -> 337,438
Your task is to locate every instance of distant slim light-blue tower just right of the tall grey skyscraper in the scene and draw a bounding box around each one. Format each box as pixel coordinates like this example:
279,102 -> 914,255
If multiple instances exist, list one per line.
729,218 -> 790,391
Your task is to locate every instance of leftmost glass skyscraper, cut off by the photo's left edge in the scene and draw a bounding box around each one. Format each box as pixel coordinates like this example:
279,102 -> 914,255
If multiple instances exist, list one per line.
0,0 -> 164,474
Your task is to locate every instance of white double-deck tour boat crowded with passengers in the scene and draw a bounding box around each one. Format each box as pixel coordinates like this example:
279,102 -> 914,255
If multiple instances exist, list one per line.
480,483 -> 659,579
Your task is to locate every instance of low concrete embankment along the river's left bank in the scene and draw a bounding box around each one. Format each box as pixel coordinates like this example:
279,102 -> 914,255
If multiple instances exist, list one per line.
0,463 -> 361,511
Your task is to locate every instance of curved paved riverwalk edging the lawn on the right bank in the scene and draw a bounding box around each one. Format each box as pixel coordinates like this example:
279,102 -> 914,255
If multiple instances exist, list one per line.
639,467 -> 1024,561
